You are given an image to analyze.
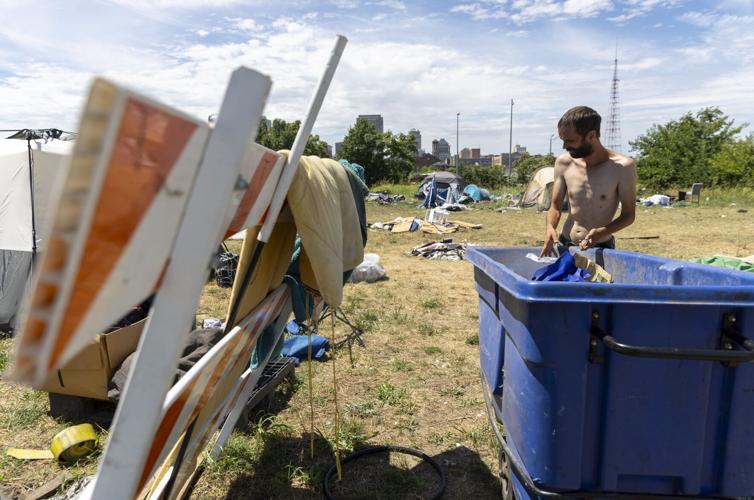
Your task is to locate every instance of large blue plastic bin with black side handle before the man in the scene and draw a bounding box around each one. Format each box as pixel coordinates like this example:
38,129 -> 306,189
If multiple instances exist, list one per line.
466,248 -> 754,497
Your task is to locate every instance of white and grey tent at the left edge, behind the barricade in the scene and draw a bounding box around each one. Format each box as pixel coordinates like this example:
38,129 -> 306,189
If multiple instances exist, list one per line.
0,139 -> 73,331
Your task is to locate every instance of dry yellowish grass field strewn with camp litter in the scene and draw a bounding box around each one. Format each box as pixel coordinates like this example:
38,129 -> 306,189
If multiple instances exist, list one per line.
0,193 -> 754,499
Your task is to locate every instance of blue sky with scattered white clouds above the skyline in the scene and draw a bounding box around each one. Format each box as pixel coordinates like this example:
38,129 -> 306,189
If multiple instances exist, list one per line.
0,0 -> 754,154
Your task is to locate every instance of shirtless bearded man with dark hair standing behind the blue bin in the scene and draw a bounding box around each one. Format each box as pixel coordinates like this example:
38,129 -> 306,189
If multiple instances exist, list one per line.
541,106 -> 636,256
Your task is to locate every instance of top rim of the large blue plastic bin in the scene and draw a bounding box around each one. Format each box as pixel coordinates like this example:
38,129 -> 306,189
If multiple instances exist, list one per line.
465,247 -> 754,307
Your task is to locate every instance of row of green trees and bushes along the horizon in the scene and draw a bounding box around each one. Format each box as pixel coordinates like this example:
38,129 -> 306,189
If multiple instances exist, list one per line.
257,107 -> 754,189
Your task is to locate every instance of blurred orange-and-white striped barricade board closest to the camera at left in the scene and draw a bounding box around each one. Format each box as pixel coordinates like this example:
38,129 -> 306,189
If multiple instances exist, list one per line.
13,79 -> 209,385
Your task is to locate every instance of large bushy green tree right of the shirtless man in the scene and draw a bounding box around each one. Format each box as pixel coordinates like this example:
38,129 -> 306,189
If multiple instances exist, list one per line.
630,107 -> 742,189
